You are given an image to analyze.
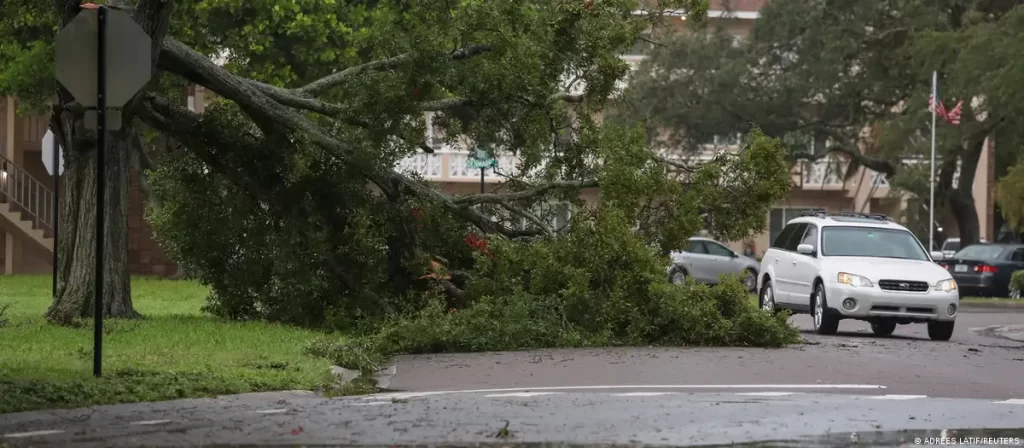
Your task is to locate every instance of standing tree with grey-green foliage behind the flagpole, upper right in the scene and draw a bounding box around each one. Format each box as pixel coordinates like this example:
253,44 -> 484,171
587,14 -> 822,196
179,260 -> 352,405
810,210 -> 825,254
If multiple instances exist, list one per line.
623,0 -> 1024,244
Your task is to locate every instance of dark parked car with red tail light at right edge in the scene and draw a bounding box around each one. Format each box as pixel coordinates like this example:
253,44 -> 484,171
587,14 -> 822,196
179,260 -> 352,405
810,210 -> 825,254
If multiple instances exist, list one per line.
939,243 -> 1024,298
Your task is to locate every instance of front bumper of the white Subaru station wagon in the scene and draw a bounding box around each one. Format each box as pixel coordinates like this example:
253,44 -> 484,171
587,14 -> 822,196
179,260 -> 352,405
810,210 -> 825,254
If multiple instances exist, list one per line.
825,281 -> 959,320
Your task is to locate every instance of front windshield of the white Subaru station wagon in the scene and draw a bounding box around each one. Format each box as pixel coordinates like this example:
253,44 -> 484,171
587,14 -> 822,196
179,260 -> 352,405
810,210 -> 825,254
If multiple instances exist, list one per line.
821,226 -> 930,261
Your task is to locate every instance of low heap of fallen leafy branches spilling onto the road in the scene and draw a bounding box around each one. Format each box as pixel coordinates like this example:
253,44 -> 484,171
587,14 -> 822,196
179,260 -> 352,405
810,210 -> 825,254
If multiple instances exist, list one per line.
306,213 -> 800,370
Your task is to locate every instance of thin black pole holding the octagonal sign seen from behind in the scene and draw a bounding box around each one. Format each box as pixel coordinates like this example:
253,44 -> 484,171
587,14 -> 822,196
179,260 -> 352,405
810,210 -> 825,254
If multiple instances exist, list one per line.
92,6 -> 106,377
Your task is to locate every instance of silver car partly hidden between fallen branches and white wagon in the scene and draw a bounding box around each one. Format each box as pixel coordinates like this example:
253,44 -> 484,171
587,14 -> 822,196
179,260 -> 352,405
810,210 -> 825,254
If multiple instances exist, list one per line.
669,237 -> 760,292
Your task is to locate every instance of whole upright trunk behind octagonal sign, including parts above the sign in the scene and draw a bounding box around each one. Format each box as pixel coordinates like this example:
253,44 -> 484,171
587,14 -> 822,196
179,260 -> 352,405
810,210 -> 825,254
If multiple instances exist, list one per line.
46,0 -> 174,323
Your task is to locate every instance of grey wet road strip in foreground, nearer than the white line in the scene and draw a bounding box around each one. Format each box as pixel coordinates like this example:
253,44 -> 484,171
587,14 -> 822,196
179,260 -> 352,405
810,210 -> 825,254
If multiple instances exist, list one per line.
0,391 -> 1024,447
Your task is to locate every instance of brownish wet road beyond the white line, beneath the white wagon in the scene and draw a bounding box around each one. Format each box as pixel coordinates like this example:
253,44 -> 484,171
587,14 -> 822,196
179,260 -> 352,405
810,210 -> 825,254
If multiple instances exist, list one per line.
388,313 -> 1024,399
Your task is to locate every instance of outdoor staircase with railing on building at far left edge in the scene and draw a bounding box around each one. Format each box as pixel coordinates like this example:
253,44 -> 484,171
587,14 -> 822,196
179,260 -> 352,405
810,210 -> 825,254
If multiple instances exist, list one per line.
0,155 -> 54,254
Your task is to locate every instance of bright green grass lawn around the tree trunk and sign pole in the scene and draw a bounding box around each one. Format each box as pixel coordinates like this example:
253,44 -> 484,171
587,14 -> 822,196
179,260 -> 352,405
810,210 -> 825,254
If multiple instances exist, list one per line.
0,276 -> 330,413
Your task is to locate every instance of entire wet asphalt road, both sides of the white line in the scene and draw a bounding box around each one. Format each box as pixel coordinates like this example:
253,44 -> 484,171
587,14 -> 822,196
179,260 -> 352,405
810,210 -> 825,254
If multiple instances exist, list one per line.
0,312 -> 1024,447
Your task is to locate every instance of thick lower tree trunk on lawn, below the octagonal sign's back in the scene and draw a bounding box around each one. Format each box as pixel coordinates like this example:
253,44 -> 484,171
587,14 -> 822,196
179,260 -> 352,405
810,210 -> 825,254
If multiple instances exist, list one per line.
46,124 -> 139,324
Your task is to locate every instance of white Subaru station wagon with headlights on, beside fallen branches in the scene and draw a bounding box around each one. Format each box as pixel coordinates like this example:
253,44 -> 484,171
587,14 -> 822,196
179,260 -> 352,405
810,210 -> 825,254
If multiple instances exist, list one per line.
758,211 -> 959,341
